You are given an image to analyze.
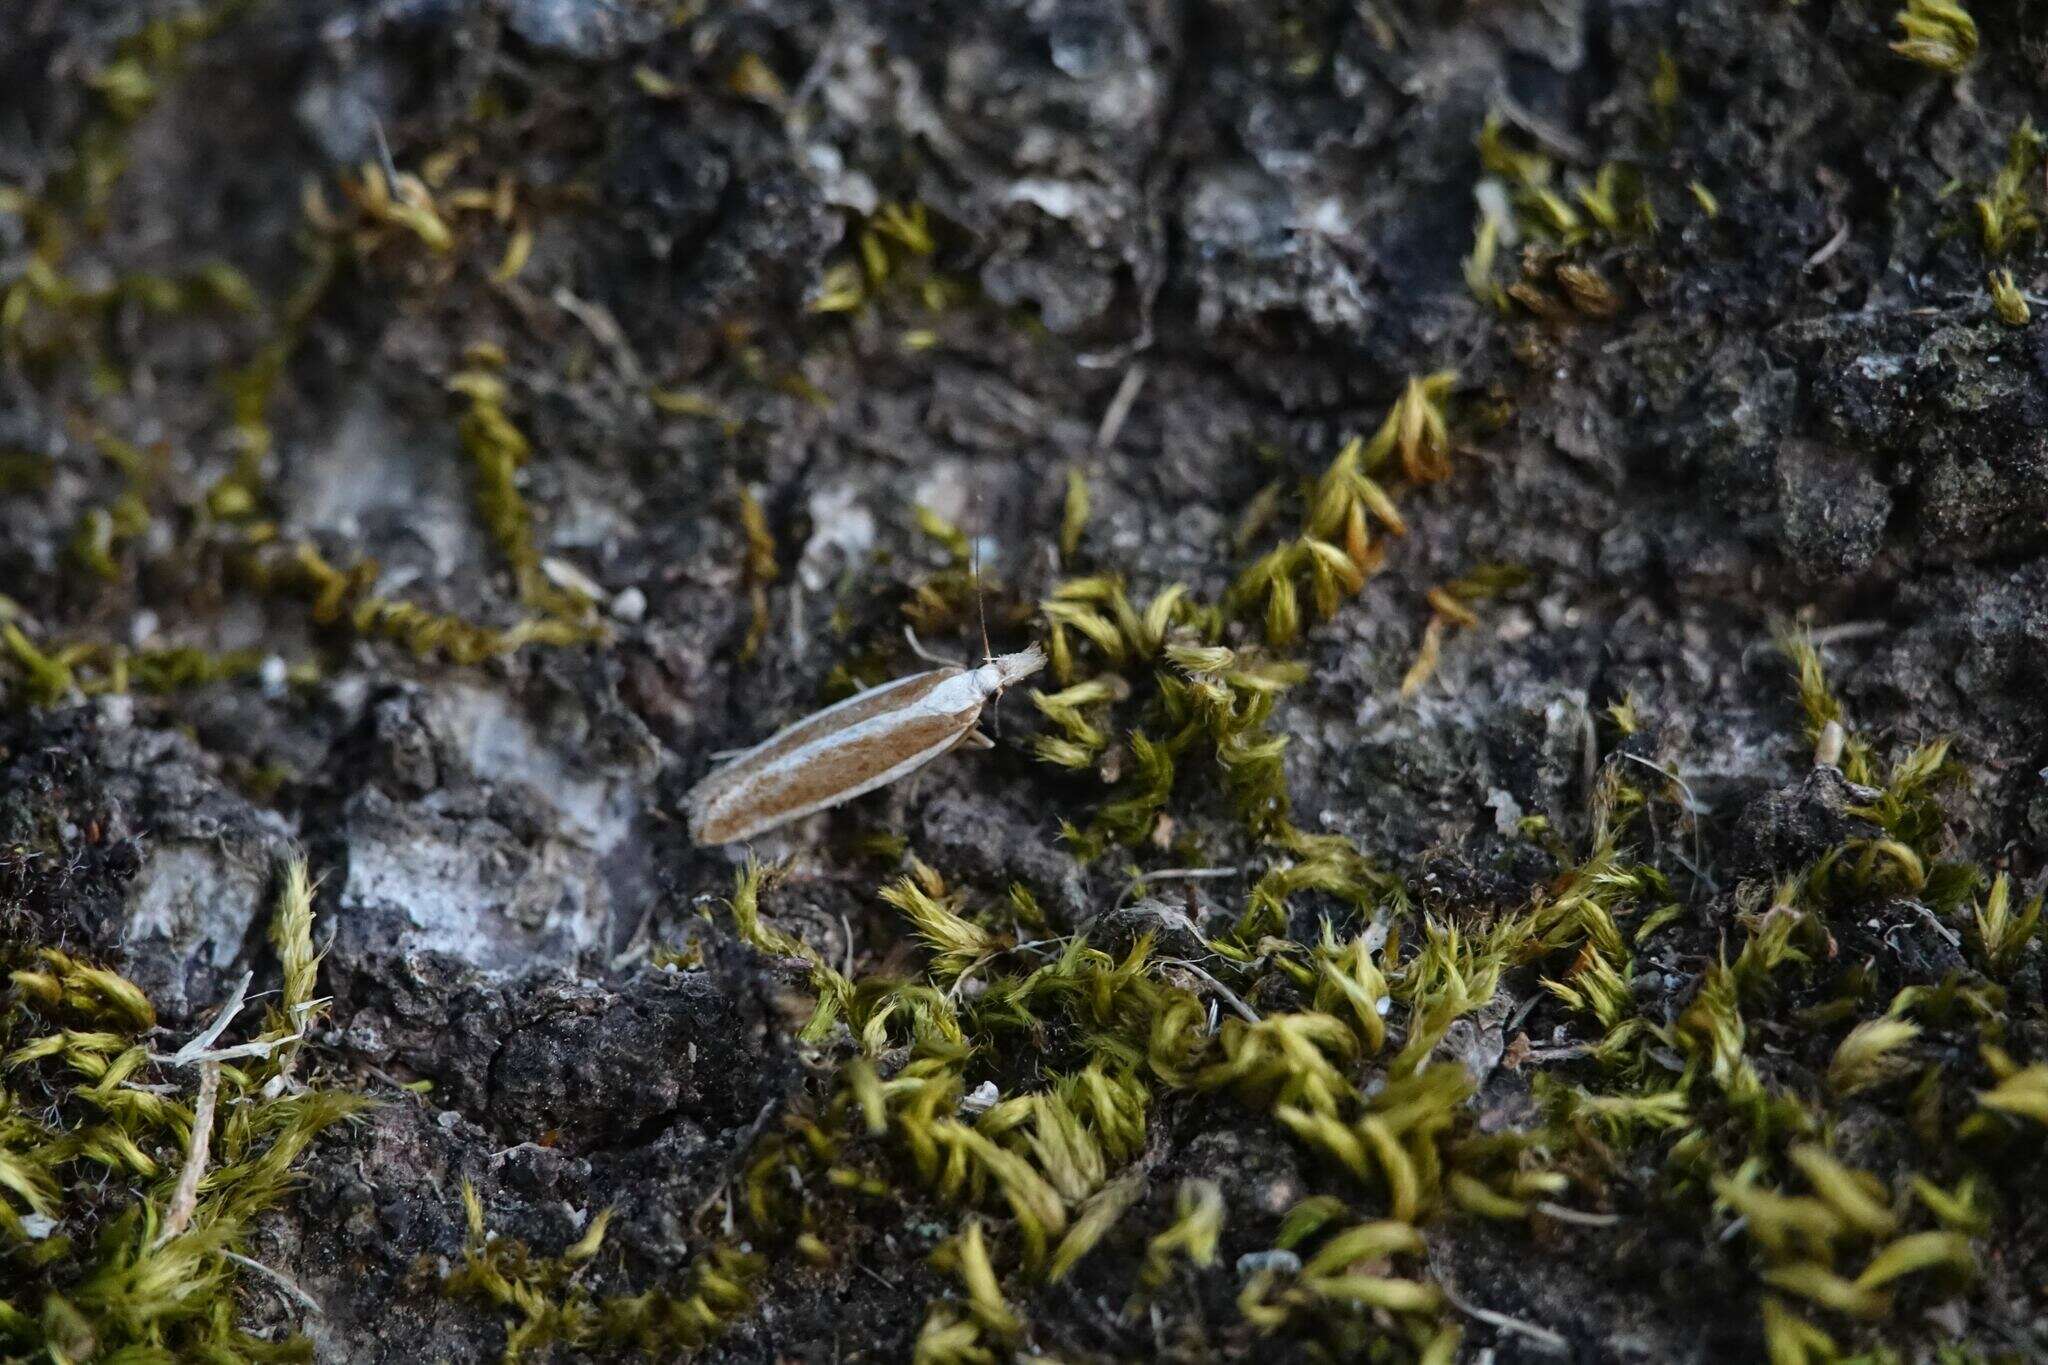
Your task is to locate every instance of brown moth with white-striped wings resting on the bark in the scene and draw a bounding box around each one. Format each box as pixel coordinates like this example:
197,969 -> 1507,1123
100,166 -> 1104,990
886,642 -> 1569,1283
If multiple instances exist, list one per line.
684,645 -> 1044,843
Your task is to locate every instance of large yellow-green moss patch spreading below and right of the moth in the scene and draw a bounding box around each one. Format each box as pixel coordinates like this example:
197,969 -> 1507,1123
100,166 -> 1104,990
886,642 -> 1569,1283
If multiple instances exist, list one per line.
684,609 -> 2048,1361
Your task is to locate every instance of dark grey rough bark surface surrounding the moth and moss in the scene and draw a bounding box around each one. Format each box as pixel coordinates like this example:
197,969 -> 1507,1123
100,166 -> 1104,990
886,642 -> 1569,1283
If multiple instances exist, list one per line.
0,0 -> 2048,1361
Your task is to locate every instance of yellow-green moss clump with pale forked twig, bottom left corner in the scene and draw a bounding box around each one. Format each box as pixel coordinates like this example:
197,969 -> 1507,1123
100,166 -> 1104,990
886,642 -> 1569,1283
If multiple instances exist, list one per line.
0,864 -> 367,1361
